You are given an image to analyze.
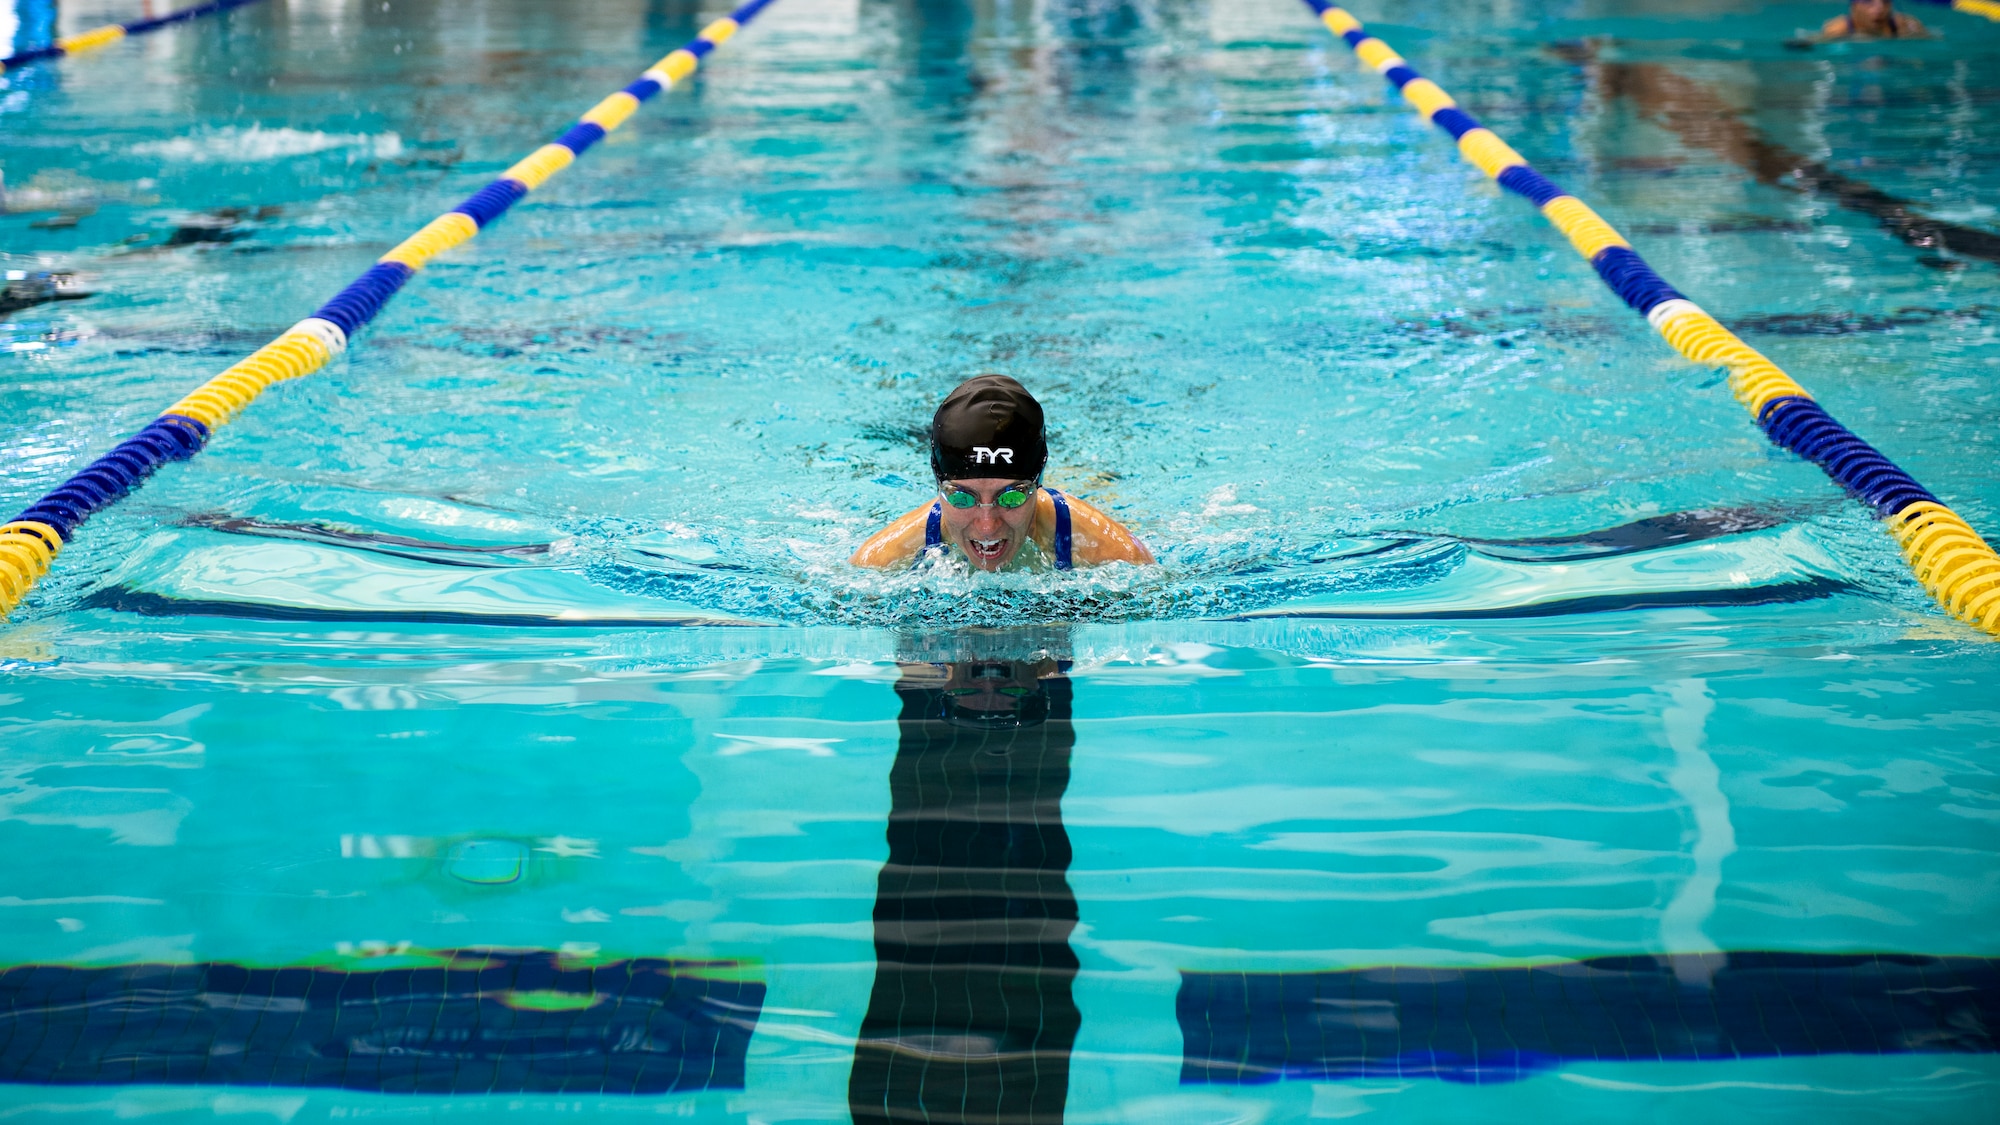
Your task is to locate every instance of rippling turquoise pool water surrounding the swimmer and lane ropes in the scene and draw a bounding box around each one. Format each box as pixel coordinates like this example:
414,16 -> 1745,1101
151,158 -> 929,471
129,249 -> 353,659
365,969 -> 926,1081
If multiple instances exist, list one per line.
0,0 -> 2000,1123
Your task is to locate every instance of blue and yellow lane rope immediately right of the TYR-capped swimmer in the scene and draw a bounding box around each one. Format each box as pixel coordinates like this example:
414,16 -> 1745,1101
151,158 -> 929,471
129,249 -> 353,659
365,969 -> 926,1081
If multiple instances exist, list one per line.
1304,0 -> 2000,635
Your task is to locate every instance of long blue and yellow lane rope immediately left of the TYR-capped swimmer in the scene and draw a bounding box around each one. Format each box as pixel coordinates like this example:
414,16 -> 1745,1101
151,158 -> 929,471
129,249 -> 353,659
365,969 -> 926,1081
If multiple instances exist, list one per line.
0,0 -> 772,615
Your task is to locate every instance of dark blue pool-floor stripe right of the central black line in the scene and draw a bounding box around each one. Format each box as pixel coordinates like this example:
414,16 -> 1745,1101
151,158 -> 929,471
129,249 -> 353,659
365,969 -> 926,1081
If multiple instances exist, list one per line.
1176,953 -> 2000,1085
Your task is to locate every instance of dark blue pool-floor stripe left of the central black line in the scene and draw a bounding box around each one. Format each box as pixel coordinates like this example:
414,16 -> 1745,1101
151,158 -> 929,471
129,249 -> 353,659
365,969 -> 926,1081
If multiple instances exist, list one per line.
0,951 -> 764,1093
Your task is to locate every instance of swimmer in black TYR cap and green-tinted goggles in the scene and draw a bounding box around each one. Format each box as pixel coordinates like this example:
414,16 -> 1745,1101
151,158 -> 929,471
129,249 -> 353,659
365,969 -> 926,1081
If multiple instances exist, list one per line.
850,374 -> 1152,571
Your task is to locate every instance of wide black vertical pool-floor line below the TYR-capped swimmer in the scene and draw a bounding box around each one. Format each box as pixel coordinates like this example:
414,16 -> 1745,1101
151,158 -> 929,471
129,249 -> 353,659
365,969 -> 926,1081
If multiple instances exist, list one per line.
848,659 -> 1078,1125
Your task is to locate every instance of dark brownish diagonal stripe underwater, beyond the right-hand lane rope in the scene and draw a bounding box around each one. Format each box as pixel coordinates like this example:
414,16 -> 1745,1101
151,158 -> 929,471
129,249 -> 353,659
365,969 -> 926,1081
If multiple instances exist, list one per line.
1556,44 -> 2000,264
